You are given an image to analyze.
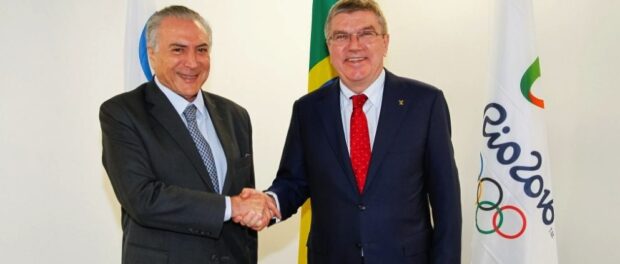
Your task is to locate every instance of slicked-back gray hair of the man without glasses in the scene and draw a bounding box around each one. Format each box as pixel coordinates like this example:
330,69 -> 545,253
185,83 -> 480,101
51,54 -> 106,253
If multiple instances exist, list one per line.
146,5 -> 211,51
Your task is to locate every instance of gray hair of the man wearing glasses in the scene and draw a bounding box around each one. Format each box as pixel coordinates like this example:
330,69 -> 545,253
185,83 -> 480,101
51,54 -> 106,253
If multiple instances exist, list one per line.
323,0 -> 388,39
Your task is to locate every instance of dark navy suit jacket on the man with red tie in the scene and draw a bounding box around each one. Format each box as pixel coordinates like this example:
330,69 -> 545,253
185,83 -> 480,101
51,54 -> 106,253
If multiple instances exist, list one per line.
269,71 -> 461,264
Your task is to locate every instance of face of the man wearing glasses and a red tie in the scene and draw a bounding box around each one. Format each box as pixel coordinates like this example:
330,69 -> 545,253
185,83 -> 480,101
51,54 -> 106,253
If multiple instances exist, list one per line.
327,11 -> 389,93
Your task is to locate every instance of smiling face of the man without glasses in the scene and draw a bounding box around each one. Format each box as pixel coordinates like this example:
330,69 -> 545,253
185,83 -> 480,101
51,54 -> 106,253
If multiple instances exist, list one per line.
148,17 -> 211,101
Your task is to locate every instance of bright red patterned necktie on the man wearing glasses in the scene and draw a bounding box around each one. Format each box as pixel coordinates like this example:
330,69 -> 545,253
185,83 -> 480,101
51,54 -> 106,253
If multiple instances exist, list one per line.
349,94 -> 370,193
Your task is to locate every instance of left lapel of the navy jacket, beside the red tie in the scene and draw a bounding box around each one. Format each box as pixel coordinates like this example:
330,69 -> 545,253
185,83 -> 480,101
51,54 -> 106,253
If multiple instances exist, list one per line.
317,79 -> 358,193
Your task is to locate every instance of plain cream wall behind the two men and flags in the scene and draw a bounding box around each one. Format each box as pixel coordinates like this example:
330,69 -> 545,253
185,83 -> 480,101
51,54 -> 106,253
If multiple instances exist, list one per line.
0,0 -> 620,264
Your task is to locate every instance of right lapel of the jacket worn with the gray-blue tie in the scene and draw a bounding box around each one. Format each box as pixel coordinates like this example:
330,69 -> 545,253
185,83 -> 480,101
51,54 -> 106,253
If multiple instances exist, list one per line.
202,91 -> 234,194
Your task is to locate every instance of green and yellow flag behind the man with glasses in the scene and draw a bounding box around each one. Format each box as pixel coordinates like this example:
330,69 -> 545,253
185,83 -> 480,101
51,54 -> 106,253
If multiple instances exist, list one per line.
298,0 -> 336,264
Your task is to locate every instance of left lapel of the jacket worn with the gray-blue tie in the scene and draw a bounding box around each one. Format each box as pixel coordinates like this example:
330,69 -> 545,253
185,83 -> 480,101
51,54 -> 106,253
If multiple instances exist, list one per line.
145,81 -> 219,190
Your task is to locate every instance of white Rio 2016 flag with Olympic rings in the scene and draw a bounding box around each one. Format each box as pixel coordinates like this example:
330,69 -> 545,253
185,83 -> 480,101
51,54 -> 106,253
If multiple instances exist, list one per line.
472,0 -> 558,264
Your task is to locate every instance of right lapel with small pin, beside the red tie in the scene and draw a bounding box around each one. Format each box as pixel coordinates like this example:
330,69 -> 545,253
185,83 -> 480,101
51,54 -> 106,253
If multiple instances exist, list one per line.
364,70 -> 413,191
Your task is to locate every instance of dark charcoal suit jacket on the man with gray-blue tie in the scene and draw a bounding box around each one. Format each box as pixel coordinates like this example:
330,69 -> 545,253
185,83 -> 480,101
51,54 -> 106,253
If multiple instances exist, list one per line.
99,81 -> 257,264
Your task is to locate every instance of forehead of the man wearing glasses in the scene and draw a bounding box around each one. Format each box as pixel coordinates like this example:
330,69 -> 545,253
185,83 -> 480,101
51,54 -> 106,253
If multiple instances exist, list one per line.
329,10 -> 380,32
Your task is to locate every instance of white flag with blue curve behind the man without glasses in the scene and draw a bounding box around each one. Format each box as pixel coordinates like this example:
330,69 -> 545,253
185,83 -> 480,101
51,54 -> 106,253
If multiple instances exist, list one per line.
125,0 -> 156,91
